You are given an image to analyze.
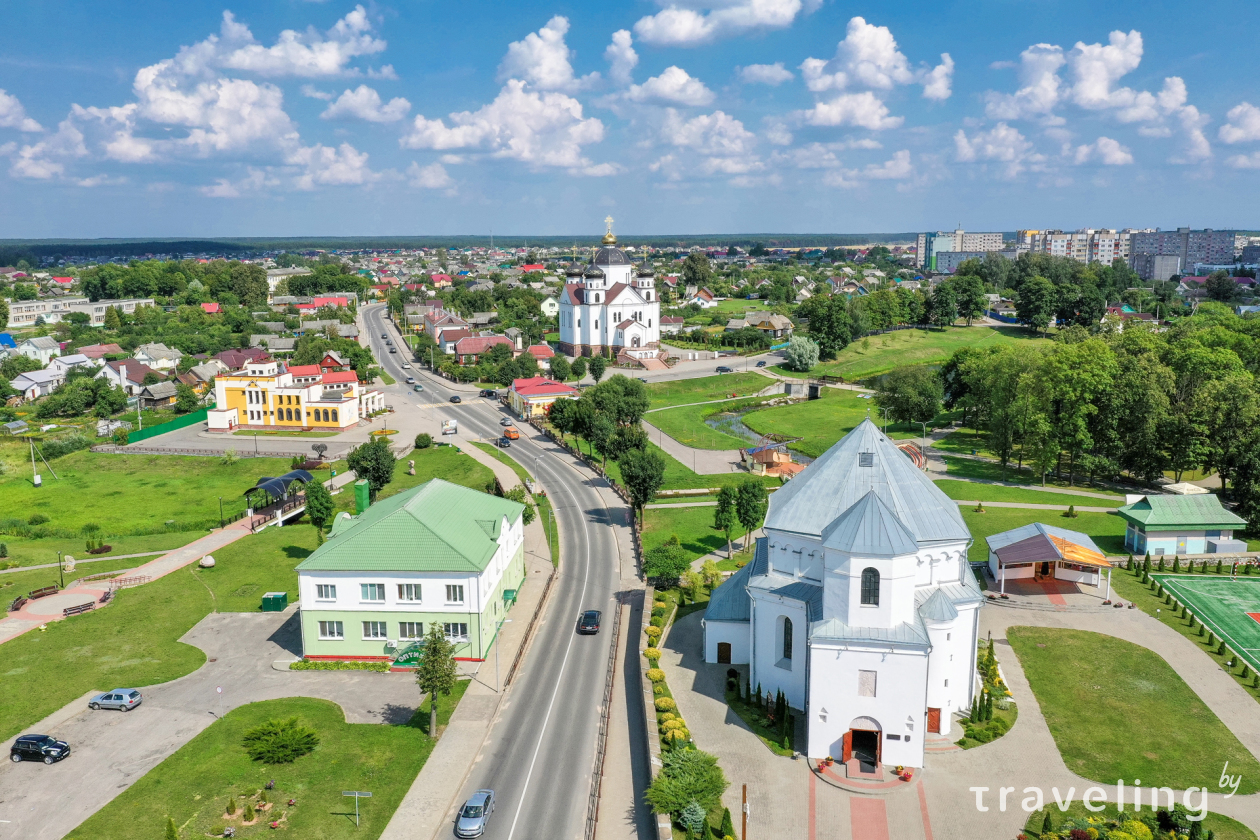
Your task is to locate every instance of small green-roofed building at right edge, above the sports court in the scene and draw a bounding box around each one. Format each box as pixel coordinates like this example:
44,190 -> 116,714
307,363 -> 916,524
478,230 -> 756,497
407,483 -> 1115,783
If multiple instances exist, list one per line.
1116,494 -> 1247,555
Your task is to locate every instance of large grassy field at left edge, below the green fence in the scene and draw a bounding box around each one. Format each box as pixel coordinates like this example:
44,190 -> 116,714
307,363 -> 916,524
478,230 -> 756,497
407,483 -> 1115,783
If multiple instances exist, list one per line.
0,451 -> 296,539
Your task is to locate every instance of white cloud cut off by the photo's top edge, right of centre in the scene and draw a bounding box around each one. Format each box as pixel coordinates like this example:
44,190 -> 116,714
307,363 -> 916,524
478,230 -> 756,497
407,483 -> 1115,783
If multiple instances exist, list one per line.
634,0 -> 820,47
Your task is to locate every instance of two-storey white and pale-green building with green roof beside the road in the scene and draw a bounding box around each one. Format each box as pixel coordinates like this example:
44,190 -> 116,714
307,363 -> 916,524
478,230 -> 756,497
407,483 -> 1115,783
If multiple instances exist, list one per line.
297,479 -> 525,665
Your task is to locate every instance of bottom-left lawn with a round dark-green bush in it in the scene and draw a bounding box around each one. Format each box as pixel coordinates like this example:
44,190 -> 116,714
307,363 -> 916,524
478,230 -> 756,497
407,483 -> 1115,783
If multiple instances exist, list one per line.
69,700 -> 435,840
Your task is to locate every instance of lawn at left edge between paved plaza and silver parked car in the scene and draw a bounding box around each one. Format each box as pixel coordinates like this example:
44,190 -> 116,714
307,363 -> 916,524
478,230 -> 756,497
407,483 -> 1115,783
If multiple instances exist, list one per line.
0,570 -> 212,741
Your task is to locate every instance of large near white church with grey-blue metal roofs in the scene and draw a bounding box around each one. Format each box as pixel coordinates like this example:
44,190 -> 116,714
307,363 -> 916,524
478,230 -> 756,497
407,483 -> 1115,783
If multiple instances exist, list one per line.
703,418 -> 983,772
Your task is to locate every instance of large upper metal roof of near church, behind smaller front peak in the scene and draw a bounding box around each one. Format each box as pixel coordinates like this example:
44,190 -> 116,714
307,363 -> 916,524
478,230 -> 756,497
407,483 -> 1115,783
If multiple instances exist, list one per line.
765,418 -> 971,544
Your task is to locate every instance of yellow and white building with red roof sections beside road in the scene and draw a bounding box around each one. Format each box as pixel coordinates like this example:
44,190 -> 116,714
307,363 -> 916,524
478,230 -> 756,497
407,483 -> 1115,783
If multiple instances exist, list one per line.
208,359 -> 384,432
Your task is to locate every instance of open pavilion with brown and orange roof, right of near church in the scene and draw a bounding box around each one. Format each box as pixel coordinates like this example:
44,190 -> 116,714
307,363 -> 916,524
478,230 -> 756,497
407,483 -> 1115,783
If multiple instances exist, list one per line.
985,523 -> 1111,601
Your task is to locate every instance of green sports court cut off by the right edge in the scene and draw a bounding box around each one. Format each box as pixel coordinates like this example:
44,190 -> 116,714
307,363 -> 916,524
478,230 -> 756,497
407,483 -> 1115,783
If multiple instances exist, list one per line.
1152,574 -> 1260,671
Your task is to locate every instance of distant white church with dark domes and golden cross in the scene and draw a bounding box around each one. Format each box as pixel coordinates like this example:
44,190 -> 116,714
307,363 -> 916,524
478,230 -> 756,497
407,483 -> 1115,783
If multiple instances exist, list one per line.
559,218 -> 660,360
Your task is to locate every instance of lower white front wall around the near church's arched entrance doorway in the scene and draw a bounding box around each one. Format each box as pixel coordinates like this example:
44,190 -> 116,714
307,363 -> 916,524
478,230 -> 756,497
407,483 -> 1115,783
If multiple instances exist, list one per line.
808,640 -> 927,767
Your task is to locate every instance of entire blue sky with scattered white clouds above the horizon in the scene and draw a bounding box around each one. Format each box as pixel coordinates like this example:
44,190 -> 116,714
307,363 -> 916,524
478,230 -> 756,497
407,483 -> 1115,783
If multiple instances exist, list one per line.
0,0 -> 1260,238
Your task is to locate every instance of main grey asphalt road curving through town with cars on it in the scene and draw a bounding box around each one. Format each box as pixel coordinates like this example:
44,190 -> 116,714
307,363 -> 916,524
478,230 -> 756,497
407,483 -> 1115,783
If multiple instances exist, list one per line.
363,306 -> 629,840
